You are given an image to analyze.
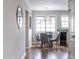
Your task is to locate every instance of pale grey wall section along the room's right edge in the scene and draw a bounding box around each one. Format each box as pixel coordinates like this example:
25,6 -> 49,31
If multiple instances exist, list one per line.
69,0 -> 75,58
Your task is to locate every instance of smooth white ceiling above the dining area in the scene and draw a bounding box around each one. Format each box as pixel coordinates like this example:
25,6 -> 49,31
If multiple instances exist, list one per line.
26,0 -> 68,10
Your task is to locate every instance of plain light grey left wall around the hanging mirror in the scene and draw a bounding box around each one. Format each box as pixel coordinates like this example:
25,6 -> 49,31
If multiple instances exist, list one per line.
3,0 -> 30,59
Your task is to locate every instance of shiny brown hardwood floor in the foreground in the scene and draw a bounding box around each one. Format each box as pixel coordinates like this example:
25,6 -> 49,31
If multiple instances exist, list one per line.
24,47 -> 69,59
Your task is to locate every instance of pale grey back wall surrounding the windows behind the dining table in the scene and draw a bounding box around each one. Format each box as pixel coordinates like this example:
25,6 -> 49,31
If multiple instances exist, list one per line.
32,10 -> 69,42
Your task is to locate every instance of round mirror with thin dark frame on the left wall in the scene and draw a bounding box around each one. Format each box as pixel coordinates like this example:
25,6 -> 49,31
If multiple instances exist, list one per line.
16,6 -> 23,29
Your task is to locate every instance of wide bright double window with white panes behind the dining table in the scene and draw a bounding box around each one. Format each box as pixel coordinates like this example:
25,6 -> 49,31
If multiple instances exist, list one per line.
36,16 -> 56,32
